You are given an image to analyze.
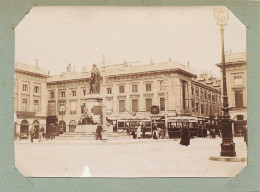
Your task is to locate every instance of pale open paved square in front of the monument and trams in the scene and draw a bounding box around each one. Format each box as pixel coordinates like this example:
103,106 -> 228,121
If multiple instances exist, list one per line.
15,137 -> 247,177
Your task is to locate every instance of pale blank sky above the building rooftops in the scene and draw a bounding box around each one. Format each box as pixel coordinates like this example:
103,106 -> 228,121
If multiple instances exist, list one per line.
15,7 -> 246,77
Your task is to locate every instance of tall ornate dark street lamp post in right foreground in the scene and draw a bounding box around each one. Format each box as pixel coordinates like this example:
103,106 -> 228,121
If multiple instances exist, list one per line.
214,7 -> 236,157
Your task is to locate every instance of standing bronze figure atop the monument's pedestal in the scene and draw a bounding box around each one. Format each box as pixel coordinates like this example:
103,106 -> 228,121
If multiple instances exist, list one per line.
89,64 -> 100,94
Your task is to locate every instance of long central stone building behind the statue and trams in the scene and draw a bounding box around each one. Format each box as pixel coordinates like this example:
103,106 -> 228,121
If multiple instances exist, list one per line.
46,60 -> 221,132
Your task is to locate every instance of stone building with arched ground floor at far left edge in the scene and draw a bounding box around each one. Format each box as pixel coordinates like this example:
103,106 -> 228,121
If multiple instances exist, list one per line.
14,62 -> 48,137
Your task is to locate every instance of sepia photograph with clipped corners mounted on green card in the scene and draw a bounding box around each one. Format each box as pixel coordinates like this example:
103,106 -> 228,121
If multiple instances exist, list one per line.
14,6 -> 248,178
